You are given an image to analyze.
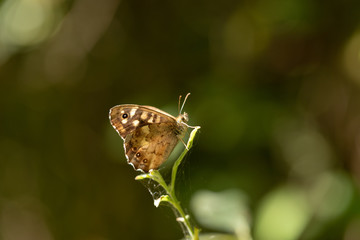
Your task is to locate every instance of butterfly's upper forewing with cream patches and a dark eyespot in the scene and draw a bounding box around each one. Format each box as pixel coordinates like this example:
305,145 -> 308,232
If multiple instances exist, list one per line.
109,104 -> 176,139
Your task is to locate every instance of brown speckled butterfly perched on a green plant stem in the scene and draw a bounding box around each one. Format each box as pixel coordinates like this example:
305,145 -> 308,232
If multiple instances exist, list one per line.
109,93 -> 190,172
